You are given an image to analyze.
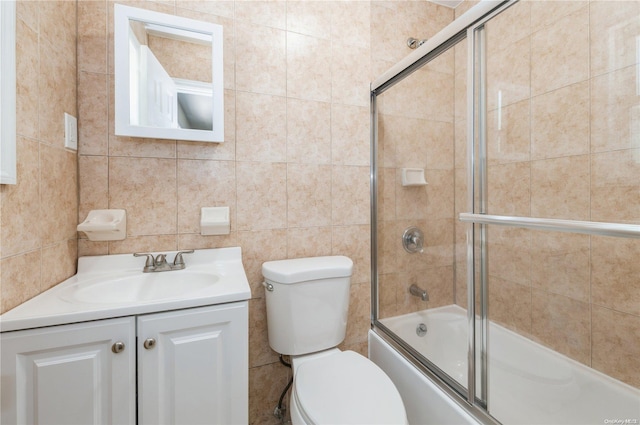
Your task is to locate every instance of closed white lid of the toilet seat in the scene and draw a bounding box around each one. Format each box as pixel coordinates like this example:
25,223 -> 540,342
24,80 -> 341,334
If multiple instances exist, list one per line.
294,351 -> 407,425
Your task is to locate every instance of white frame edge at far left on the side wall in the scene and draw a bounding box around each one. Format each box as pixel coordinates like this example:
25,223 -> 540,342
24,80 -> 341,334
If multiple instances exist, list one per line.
0,0 -> 17,184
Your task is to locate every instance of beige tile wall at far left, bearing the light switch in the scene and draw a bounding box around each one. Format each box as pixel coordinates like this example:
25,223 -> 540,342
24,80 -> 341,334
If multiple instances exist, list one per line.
0,1 -> 78,313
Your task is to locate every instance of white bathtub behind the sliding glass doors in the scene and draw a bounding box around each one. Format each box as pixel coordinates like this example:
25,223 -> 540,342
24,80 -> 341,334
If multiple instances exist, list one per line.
369,305 -> 640,425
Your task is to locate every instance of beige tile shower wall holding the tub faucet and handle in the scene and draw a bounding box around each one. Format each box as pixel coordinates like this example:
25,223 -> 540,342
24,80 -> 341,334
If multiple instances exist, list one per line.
372,3 -> 454,318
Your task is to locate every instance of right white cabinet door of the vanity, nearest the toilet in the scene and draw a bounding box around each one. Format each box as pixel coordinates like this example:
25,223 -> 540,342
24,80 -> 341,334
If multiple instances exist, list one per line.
138,302 -> 248,425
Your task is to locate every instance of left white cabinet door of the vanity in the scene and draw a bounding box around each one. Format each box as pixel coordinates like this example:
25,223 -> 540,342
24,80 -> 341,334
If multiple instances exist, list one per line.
0,318 -> 136,425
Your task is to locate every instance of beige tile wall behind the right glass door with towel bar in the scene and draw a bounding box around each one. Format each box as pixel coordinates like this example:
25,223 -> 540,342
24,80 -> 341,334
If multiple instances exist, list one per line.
456,1 -> 640,387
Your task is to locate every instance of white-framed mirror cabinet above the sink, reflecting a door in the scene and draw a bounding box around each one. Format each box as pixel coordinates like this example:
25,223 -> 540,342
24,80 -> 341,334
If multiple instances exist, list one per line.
114,4 -> 224,142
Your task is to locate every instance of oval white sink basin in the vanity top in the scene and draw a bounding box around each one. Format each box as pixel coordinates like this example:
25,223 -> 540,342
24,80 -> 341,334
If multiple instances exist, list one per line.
59,270 -> 220,304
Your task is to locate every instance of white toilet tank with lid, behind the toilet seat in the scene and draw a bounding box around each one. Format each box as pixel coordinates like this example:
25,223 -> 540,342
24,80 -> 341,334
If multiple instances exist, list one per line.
262,256 -> 353,355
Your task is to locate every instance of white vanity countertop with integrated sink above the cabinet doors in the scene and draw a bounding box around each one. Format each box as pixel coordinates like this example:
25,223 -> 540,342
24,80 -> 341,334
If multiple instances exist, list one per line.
0,247 -> 251,332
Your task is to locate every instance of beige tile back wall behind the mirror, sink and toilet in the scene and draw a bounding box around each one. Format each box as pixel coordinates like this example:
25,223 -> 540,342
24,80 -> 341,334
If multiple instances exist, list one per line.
72,0 -> 440,423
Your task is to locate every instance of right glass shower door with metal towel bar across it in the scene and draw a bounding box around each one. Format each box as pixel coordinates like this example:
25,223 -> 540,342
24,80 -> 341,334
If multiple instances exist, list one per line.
461,1 -> 640,424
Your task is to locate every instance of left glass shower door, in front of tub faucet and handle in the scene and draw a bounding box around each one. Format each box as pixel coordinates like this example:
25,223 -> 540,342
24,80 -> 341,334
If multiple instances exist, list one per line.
374,32 -> 468,392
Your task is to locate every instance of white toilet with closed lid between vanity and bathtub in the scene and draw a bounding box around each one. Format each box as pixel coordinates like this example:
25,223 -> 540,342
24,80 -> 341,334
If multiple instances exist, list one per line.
262,256 -> 407,425
